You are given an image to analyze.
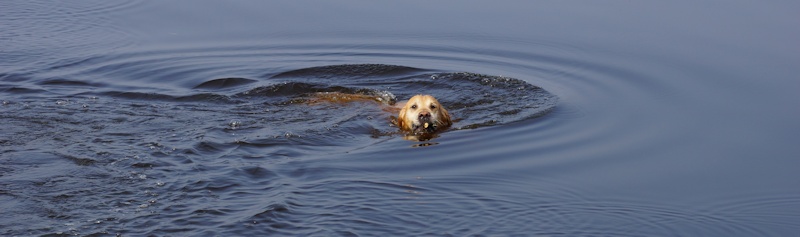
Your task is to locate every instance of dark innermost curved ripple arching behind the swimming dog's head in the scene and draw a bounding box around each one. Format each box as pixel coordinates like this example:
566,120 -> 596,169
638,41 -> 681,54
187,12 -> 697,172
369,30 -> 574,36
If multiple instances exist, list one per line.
242,64 -> 557,129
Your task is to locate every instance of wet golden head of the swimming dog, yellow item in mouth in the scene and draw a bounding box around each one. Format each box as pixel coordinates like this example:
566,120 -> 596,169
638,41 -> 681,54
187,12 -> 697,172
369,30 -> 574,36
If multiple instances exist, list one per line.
397,95 -> 452,133
